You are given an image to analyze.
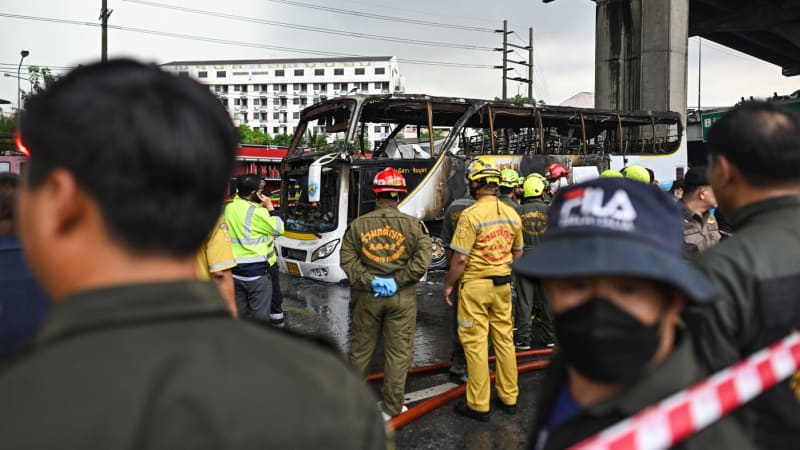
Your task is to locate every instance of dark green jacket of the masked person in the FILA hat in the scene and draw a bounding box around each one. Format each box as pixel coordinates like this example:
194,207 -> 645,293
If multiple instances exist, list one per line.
530,332 -> 755,450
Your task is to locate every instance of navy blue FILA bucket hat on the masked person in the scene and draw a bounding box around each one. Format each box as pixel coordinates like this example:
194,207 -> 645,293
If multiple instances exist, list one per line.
514,178 -> 717,302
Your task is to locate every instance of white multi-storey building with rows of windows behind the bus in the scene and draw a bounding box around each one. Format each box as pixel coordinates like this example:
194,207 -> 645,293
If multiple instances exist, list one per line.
162,56 -> 405,140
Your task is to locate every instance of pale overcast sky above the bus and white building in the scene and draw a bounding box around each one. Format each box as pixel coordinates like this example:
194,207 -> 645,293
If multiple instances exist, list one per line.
0,0 -> 800,111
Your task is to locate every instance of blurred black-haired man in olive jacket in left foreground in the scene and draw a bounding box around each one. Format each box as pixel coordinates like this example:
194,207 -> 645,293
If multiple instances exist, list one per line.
0,60 -> 385,450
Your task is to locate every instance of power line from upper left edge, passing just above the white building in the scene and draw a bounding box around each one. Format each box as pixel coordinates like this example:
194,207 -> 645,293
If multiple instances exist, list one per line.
0,13 -> 492,69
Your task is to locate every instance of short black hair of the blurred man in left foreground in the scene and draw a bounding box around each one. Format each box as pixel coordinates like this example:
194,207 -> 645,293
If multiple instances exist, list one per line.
20,59 -> 237,256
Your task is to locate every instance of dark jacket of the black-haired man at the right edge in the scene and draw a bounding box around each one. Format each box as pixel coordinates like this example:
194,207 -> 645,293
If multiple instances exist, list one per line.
686,195 -> 800,448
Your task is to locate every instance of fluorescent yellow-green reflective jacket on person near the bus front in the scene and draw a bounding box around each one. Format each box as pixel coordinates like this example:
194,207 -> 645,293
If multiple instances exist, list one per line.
225,196 -> 283,266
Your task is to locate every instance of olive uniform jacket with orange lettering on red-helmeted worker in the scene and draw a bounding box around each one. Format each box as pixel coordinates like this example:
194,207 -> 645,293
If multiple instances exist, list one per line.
339,206 -> 432,295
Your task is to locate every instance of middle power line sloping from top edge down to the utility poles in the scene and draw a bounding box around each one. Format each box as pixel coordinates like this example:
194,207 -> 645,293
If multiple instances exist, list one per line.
123,0 -> 493,52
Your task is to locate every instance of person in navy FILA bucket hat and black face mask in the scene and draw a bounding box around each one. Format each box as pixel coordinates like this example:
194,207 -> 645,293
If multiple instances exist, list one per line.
514,178 -> 751,449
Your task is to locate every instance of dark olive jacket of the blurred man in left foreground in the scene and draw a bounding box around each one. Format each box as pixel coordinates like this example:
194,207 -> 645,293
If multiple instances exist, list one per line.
0,281 -> 385,450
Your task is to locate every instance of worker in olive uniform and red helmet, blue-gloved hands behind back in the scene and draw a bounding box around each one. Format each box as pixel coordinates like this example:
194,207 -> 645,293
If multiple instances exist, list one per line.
339,167 -> 433,420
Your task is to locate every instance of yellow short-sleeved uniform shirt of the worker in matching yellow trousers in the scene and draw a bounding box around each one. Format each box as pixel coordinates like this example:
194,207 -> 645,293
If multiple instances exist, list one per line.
450,196 -> 523,281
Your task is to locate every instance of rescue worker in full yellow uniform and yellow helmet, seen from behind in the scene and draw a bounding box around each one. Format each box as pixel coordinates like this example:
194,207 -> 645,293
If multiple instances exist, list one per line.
444,157 -> 523,422
